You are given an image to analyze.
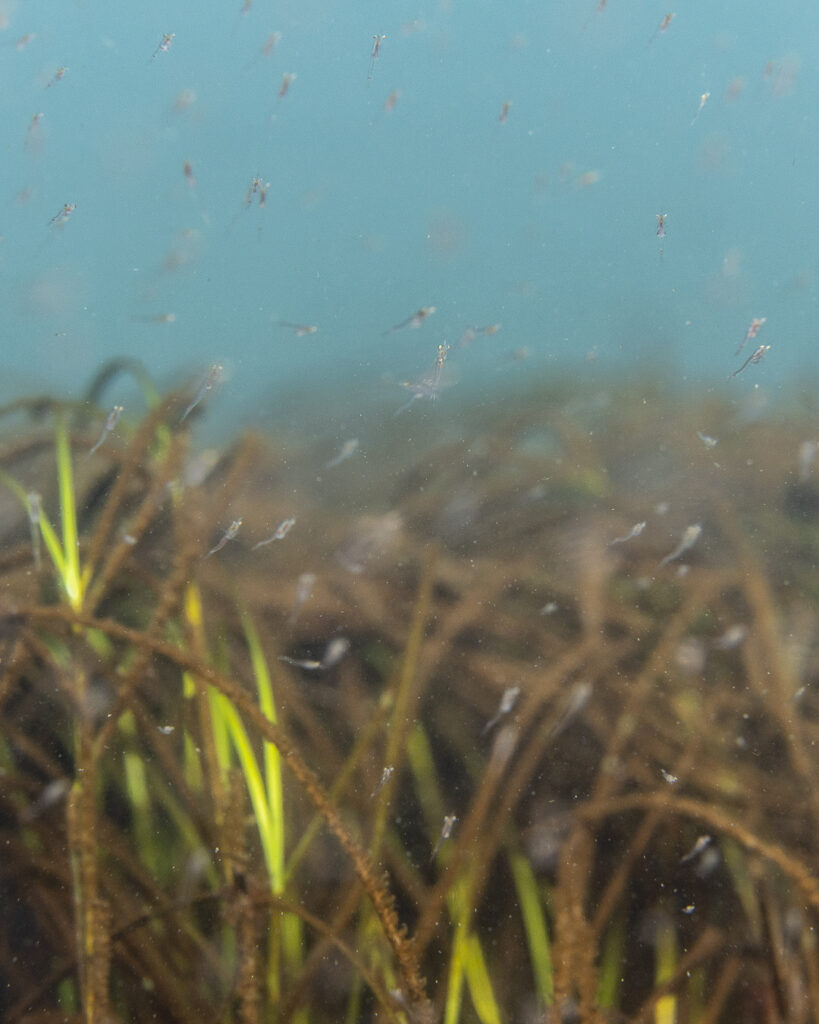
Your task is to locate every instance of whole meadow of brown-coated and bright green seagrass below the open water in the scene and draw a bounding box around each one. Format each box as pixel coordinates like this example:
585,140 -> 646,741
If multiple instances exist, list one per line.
0,365 -> 819,1024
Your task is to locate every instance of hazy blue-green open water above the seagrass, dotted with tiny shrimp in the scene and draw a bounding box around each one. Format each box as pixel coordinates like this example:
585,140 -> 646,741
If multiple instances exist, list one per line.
0,0 -> 819,432
